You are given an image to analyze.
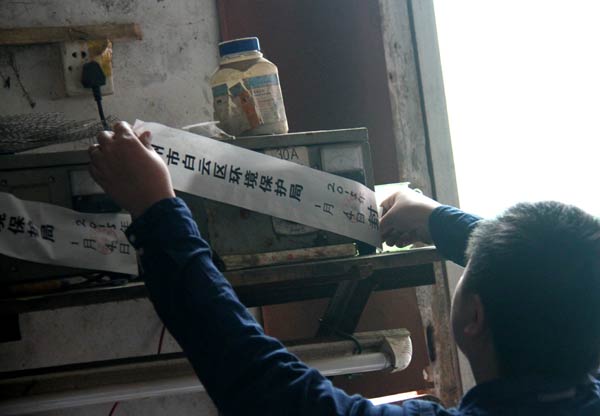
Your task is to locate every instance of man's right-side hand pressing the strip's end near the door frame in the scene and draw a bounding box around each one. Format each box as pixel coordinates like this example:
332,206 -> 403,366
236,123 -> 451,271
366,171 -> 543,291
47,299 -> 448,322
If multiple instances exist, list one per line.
379,188 -> 441,247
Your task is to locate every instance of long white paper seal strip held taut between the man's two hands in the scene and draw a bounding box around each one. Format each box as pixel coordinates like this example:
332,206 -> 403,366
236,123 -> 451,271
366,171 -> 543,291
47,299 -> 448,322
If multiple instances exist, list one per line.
134,120 -> 381,246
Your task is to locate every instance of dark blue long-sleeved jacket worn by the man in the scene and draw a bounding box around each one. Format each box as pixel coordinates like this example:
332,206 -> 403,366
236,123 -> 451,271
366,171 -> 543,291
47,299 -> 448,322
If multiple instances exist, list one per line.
127,198 -> 600,416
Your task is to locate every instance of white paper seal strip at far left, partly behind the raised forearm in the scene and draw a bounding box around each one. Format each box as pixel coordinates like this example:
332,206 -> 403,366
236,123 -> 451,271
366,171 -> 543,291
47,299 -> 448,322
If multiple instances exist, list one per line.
0,192 -> 138,275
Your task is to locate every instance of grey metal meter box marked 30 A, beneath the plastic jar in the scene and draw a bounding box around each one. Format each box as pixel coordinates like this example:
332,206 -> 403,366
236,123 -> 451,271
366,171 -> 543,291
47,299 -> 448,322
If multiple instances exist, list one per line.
205,128 -> 374,257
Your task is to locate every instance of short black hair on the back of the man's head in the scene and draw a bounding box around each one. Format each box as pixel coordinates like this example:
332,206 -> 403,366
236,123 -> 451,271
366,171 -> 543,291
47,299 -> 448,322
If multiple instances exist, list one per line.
464,202 -> 600,377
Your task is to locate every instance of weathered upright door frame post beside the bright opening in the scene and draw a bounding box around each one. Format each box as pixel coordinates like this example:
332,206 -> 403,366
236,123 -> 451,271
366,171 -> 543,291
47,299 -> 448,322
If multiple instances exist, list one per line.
379,0 -> 461,405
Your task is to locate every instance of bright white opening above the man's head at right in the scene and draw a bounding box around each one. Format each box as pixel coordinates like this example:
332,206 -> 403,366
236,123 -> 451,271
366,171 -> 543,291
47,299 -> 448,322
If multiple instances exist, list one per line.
434,0 -> 600,216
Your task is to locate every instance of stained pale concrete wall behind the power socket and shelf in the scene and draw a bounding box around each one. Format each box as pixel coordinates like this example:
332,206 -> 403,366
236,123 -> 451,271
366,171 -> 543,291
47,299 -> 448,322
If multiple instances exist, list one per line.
0,0 -> 223,415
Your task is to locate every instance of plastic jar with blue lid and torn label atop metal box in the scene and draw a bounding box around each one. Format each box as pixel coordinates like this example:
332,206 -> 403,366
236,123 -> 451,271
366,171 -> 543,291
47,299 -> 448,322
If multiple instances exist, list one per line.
211,38 -> 288,136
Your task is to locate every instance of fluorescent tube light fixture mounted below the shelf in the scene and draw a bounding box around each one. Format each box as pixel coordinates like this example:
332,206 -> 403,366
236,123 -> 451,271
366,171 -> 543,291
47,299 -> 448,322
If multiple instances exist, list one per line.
0,329 -> 412,415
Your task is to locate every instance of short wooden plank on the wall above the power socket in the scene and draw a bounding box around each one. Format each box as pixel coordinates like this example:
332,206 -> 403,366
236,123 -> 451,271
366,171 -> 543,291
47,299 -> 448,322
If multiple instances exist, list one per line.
0,23 -> 142,45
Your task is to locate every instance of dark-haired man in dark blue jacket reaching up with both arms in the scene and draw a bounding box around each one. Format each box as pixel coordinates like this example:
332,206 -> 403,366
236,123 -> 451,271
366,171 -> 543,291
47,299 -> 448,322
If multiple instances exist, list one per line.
90,123 -> 600,416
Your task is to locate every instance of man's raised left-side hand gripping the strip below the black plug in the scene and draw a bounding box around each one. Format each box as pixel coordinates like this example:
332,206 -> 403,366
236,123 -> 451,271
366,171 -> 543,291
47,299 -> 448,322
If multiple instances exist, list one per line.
88,122 -> 175,218
